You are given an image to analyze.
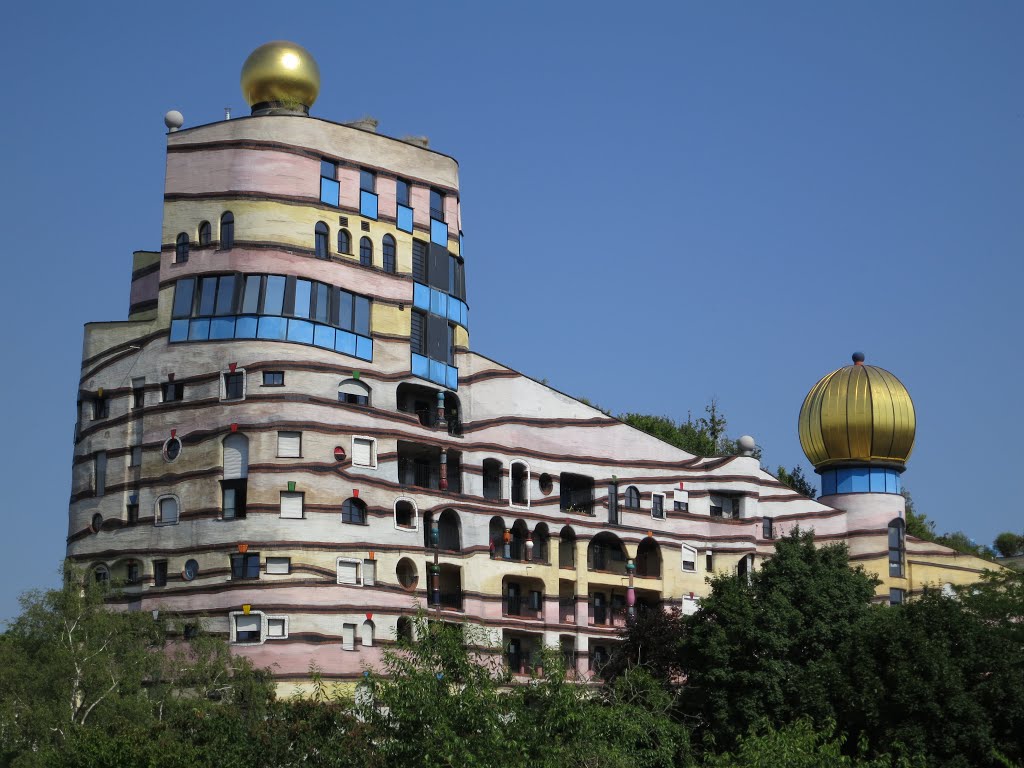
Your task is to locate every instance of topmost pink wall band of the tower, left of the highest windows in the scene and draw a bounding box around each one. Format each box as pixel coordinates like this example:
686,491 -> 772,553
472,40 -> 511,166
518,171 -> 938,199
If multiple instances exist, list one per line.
165,148 -> 315,200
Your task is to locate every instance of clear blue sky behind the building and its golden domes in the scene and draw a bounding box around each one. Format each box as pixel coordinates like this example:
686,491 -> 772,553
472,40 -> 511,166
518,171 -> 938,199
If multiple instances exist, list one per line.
0,0 -> 1024,618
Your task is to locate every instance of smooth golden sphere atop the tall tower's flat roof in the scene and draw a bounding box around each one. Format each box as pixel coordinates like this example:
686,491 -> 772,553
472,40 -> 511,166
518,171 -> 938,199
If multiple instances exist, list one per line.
242,40 -> 319,112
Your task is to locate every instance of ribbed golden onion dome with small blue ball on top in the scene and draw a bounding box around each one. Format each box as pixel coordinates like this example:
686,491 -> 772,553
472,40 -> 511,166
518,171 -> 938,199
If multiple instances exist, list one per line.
800,352 -> 916,470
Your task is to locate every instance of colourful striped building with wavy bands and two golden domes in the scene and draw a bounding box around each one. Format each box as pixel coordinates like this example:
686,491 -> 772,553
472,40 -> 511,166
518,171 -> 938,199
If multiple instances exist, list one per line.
68,42 -> 984,684
